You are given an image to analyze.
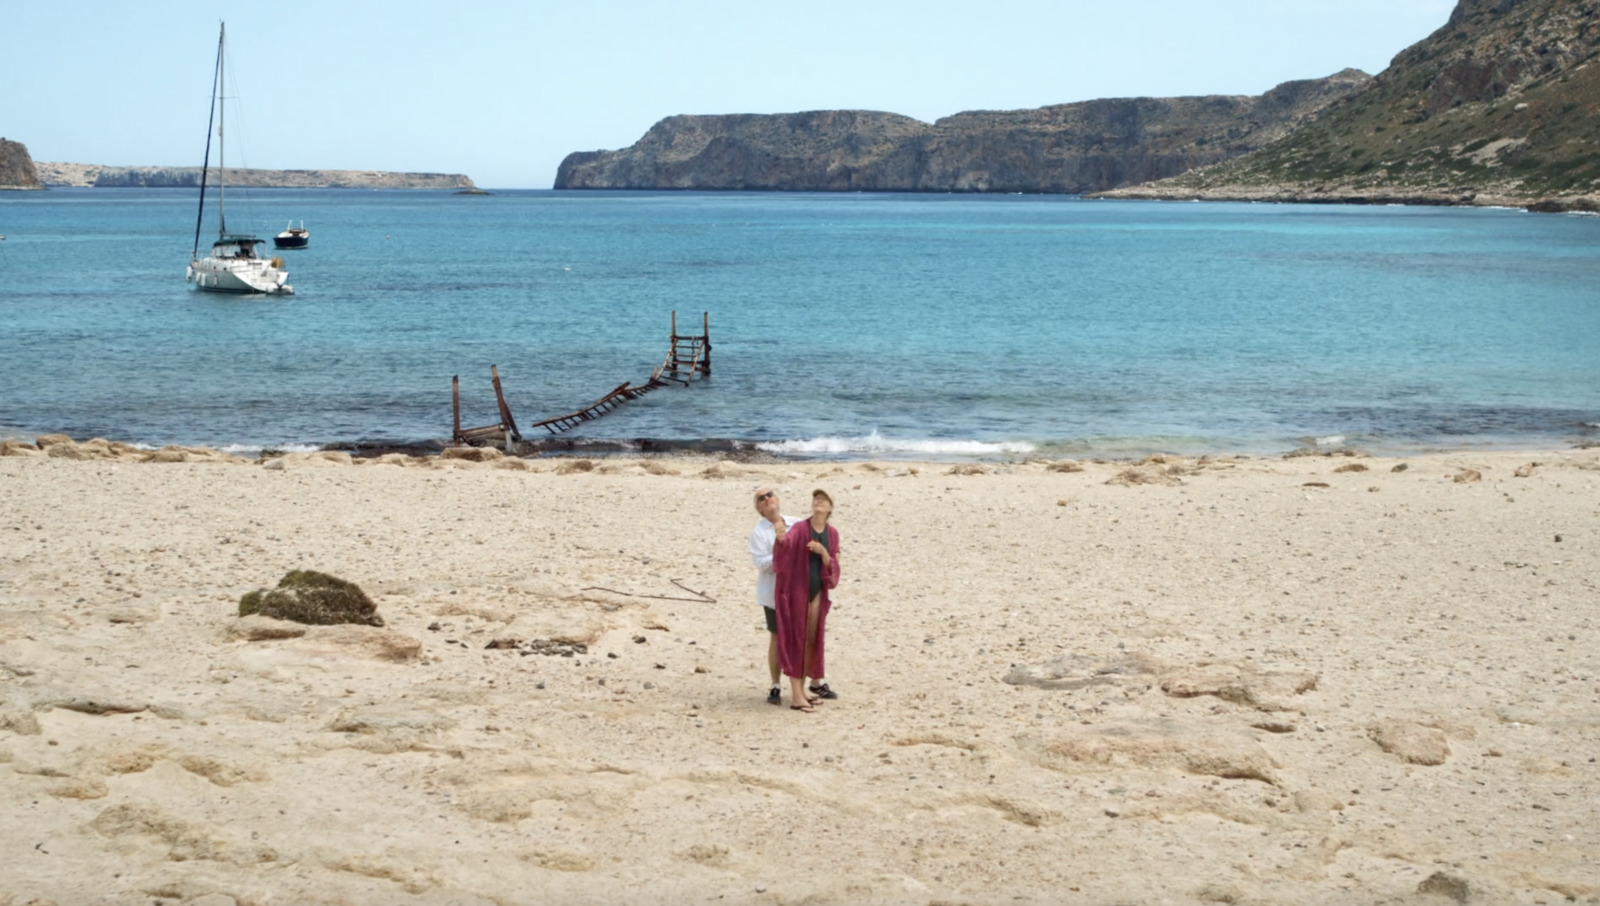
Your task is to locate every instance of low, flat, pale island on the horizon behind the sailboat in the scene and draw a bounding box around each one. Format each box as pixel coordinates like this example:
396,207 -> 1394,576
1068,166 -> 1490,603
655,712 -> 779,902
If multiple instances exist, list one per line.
37,160 -> 474,189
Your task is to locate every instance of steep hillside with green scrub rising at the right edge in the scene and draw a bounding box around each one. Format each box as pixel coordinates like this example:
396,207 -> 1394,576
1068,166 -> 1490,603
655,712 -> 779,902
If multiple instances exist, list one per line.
1109,0 -> 1600,210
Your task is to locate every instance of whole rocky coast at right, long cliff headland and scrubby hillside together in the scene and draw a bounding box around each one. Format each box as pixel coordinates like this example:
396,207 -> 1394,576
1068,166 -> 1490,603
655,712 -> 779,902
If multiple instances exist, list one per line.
555,0 -> 1600,211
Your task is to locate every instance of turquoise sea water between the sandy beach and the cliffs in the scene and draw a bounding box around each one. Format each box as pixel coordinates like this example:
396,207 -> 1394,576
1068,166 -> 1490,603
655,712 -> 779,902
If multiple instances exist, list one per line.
0,189 -> 1600,456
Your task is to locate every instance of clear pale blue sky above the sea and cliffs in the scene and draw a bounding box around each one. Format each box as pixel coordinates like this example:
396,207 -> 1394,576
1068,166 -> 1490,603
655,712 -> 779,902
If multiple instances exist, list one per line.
0,0 -> 1454,187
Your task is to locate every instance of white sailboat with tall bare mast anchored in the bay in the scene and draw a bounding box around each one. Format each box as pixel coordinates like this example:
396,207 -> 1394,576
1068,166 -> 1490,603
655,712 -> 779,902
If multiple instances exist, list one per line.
184,22 -> 294,296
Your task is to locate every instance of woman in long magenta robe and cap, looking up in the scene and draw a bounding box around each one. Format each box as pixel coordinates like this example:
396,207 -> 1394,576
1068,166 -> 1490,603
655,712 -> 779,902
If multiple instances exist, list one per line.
773,488 -> 838,714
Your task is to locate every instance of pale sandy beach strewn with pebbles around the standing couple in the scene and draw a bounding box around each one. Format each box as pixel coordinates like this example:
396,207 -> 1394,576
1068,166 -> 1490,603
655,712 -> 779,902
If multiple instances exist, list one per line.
0,443 -> 1600,906
